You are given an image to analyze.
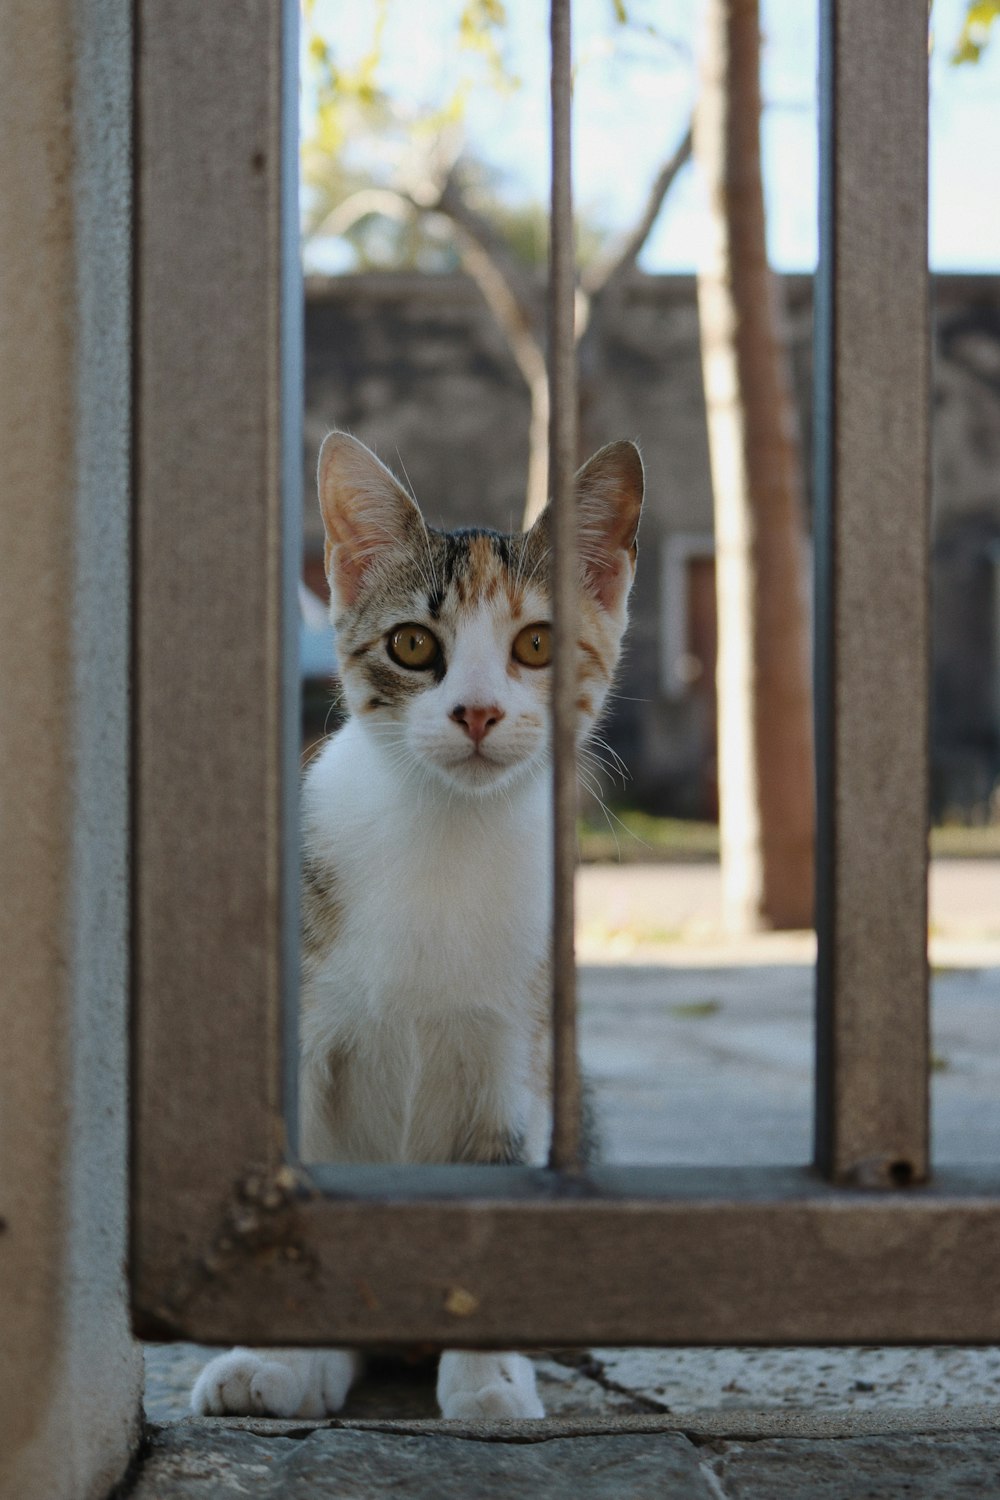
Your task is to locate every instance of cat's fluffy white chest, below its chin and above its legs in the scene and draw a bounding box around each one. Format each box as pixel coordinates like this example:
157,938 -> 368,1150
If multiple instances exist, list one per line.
307,725 -> 550,1023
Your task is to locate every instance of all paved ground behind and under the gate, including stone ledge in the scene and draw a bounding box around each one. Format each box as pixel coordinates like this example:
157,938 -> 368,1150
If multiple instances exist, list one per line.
133,861 -> 1000,1500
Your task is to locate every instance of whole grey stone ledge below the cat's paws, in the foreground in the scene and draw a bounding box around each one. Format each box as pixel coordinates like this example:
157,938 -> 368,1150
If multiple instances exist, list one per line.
129,1409 -> 1000,1500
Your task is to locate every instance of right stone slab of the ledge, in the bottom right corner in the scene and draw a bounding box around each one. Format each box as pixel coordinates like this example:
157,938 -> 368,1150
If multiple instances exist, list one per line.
705,1433 -> 1000,1500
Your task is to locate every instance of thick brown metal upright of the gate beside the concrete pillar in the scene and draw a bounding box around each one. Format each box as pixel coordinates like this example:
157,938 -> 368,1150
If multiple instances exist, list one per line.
132,0 -> 301,1299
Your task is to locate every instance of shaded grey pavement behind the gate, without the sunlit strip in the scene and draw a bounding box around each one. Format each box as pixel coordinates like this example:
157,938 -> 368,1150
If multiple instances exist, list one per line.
580,948 -> 1000,1166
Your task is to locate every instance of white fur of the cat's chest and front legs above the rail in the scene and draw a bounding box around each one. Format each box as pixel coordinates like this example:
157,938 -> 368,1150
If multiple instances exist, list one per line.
301,708 -> 550,1163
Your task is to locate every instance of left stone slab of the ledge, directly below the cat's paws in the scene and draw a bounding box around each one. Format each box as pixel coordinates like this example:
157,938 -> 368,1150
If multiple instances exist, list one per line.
130,1418 -> 718,1500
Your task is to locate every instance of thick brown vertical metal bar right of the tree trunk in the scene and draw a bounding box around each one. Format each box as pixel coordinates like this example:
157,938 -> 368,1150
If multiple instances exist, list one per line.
816,0 -> 930,1185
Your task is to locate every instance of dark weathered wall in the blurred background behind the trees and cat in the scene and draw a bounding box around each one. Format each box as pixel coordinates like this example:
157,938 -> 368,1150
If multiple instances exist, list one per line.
306,264 -> 1000,813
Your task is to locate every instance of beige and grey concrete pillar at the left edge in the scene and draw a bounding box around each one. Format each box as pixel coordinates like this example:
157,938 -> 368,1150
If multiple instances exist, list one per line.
0,0 -> 141,1500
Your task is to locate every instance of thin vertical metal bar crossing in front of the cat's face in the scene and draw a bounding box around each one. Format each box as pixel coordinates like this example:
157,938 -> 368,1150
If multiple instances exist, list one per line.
549,0 -> 580,1172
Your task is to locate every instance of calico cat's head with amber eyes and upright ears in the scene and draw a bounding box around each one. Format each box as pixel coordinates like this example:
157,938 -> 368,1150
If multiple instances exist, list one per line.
319,432 -> 643,794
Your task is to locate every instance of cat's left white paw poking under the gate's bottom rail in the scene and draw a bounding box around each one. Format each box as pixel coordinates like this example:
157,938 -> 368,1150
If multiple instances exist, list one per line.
190,1349 -> 355,1418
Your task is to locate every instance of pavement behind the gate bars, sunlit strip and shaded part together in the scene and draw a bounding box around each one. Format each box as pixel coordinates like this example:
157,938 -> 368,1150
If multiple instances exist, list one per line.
577,860 -> 1000,1166
